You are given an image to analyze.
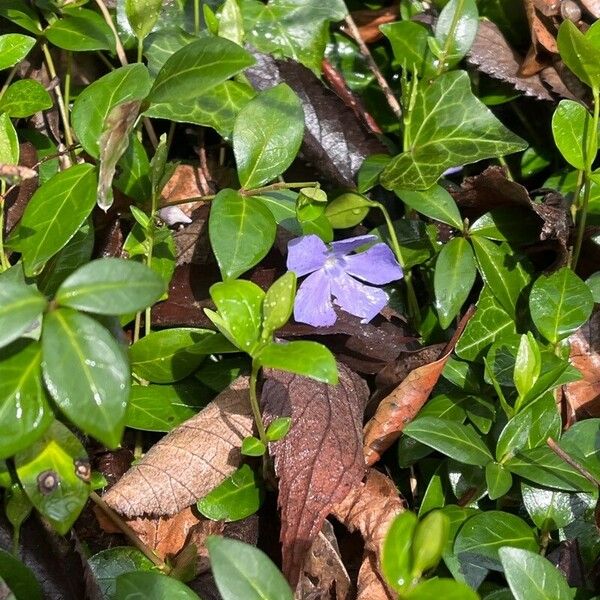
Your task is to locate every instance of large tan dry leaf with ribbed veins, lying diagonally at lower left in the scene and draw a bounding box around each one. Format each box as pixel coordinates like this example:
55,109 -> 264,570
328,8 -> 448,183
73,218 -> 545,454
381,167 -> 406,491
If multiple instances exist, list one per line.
104,377 -> 253,517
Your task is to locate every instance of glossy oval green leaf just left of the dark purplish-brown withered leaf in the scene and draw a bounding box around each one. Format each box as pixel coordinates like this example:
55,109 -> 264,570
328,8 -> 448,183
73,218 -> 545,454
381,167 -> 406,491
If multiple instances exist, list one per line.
233,83 -> 304,189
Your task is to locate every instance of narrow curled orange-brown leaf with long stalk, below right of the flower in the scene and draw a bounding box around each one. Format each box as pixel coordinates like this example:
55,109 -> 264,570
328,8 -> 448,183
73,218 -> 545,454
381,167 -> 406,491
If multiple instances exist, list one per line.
364,307 -> 475,466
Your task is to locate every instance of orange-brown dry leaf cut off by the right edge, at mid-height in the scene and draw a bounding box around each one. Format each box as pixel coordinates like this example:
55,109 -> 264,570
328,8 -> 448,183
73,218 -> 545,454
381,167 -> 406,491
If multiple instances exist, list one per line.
564,312 -> 600,418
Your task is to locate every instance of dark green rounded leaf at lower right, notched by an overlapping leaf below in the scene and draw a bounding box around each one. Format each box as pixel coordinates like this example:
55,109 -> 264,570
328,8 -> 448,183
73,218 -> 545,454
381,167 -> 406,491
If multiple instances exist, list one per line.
454,510 -> 538,571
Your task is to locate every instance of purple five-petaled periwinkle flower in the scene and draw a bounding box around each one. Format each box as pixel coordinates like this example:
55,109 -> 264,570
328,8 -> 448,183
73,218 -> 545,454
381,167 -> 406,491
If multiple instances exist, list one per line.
287,235 -> 402,327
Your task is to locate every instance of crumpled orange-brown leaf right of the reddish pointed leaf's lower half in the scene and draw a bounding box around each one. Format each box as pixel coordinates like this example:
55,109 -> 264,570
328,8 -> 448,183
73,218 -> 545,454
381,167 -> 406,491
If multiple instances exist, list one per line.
331,469 -> 406,557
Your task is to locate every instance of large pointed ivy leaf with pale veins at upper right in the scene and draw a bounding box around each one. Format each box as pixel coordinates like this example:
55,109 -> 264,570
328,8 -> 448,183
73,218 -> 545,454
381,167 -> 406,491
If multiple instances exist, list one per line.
381,71 -> 526,190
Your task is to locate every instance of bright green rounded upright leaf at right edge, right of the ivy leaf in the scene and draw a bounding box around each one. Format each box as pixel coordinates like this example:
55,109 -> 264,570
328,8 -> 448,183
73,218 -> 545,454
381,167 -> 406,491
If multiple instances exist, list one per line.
552,100 -> 598,170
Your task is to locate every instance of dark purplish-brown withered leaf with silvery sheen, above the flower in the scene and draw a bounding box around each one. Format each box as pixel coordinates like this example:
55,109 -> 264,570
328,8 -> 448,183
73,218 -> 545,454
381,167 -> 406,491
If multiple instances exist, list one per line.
245,52 -> 388,187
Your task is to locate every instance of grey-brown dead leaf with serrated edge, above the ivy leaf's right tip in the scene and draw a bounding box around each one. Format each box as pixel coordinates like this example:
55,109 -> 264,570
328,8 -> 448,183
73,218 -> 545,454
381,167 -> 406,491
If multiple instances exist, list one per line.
468,20 -> 552,100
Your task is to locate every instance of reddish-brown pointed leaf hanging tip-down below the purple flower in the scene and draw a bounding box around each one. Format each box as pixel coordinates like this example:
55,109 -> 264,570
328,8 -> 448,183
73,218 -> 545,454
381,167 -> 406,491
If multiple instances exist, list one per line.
262,364 -> 368,586
